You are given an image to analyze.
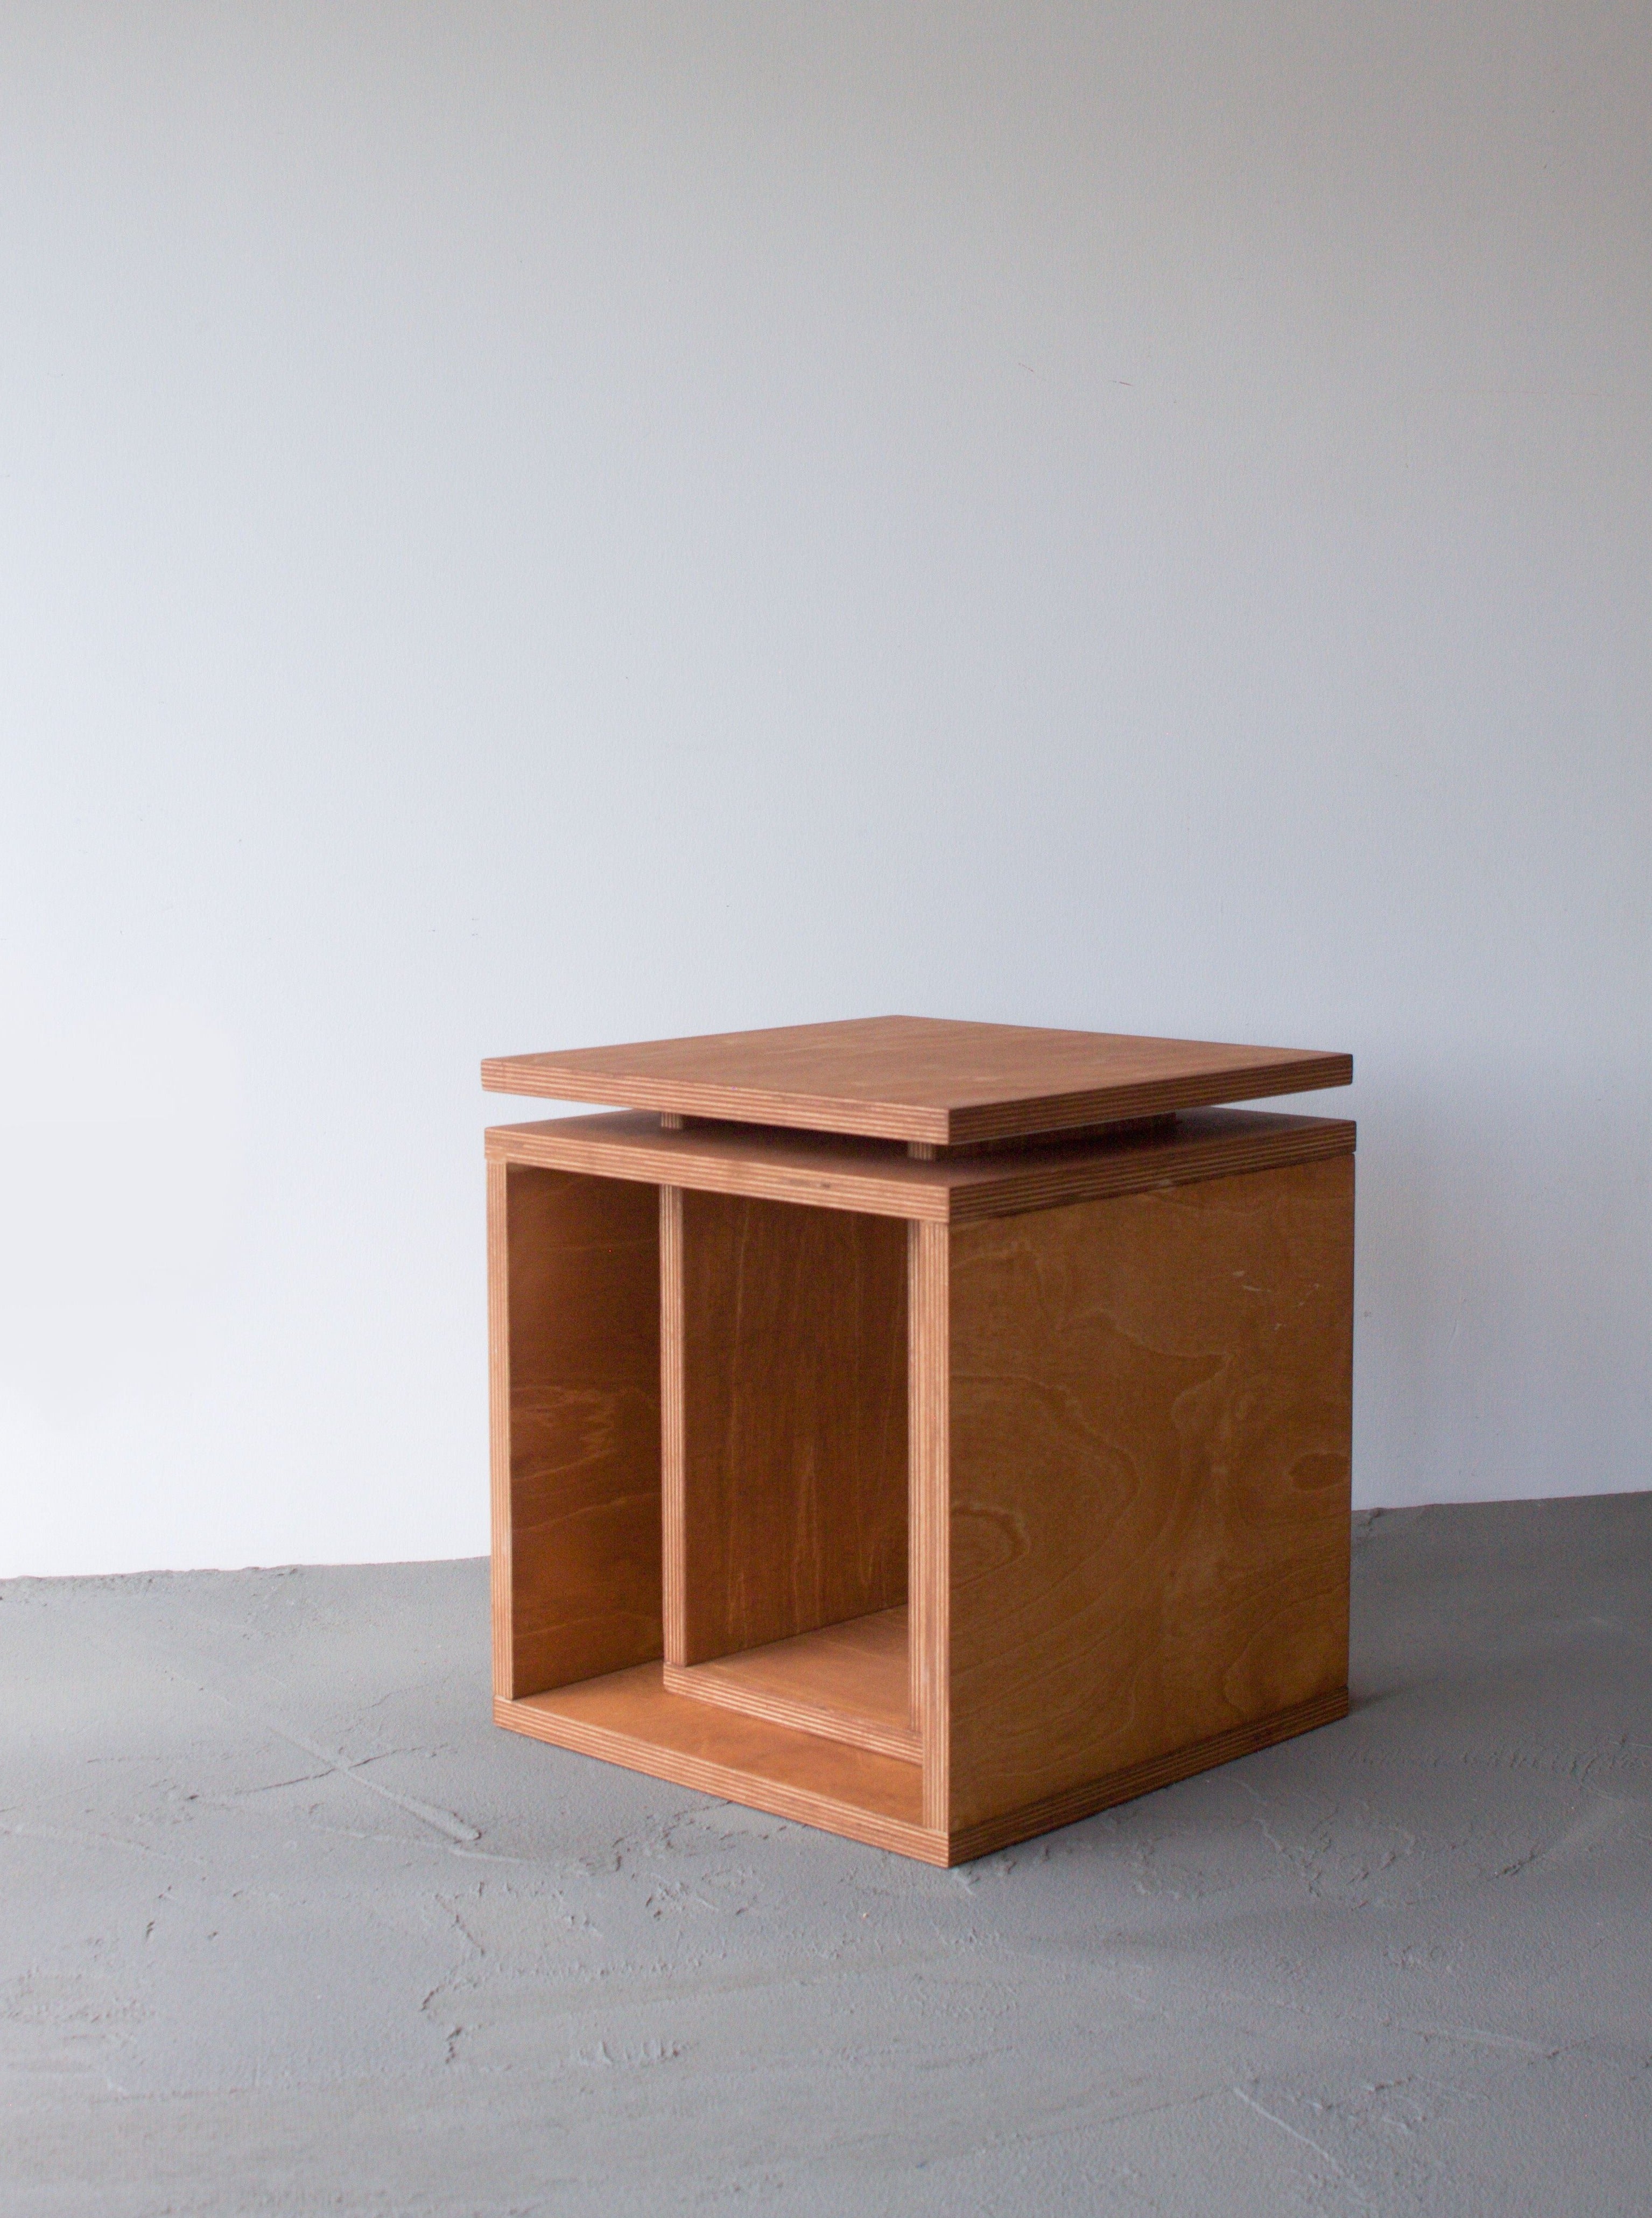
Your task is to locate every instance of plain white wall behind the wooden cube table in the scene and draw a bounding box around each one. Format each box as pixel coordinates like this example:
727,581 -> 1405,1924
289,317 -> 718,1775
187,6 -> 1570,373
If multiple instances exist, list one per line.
0,0 -> 1652,1573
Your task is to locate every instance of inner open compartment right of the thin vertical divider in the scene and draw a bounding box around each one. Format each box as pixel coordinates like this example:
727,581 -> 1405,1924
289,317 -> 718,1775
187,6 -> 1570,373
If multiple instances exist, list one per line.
661,1189 -> 920,1763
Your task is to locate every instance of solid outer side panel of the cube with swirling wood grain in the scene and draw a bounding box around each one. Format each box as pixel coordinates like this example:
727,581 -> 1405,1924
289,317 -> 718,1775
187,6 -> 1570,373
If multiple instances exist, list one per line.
949,1156 -> 1353,1841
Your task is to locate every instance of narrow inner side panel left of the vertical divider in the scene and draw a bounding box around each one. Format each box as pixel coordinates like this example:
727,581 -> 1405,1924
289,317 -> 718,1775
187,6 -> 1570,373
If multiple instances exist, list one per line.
495,1164 -> 661,1697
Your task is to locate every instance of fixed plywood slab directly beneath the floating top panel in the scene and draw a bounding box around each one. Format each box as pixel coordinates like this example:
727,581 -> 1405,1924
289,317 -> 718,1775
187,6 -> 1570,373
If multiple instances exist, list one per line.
486,1109 -> 1355,1224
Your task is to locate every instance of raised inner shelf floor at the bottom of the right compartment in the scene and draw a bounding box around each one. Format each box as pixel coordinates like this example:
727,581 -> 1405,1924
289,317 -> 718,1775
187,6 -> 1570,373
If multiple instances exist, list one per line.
665,1606 -> 923,1763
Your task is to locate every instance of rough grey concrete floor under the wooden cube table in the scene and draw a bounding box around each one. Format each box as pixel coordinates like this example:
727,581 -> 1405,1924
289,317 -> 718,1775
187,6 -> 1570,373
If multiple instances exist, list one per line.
0,1495 -> 1652,2218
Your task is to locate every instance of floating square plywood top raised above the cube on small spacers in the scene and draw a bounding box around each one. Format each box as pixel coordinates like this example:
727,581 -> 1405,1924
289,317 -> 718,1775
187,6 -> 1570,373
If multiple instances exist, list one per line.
481,1016 -> 1353,1147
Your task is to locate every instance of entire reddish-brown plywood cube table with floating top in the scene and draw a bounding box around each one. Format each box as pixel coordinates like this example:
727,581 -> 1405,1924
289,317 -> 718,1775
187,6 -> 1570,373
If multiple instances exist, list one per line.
483,1016 -> 1355,1863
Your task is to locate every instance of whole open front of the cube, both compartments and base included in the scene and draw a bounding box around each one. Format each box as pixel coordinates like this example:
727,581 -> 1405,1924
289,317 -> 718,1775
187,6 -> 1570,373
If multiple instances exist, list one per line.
490,1160 -> 926,1861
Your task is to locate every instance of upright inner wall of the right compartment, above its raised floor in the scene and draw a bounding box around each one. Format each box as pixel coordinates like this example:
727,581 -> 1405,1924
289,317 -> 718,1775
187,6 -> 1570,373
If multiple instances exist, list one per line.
665,1194 -> 907,1663
